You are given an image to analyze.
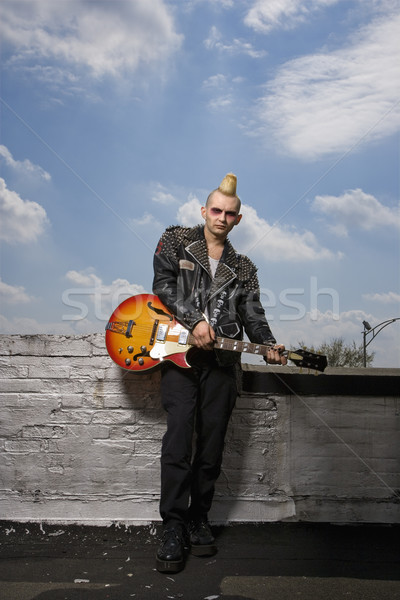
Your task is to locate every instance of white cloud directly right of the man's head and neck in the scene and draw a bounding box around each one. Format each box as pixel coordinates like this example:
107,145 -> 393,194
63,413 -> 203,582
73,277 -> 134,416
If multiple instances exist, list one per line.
231,205 -> 340,262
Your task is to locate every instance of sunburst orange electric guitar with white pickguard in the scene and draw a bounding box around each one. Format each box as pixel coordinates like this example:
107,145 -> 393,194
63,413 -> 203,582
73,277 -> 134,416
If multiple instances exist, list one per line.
106,294 -> 327,372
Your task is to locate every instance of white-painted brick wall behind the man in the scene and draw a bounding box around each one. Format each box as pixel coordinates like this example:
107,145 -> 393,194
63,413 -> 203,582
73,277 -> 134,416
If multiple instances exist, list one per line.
0,335 -> 400,524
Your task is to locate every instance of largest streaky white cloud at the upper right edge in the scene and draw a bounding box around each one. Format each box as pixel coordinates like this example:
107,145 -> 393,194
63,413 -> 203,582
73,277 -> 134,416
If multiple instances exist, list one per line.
257,14 -> 400,159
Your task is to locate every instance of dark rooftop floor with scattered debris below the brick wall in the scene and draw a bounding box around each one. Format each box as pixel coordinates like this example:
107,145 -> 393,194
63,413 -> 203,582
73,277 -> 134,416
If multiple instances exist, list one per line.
0,521 -> 400,600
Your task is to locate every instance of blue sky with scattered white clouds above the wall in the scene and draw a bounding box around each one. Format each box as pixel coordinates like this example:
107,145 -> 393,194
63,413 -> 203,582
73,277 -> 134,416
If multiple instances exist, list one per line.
0,0 -> 400,367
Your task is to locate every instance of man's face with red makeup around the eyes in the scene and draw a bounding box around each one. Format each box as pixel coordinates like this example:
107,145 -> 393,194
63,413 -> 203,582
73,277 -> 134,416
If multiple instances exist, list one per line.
201,191 -> 242,239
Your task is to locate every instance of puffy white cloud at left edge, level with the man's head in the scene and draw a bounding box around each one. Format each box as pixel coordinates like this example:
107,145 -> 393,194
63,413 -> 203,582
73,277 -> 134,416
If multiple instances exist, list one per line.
0,177 -> 48,244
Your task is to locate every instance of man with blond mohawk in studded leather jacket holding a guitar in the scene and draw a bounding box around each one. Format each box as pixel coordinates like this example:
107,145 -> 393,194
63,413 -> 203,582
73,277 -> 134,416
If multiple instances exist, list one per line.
153,173 -> 286,573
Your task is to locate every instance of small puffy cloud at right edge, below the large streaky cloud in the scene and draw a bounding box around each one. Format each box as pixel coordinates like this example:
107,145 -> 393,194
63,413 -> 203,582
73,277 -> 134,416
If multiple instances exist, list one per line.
312,189 -> 400,236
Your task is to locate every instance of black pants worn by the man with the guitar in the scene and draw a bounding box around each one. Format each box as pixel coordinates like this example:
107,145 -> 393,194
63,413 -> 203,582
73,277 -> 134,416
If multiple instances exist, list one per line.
160,352 -> 237,524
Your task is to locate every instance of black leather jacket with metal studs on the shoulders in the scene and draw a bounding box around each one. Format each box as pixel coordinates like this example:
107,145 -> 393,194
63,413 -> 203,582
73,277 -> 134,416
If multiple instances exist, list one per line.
153,225 -> 276,365
